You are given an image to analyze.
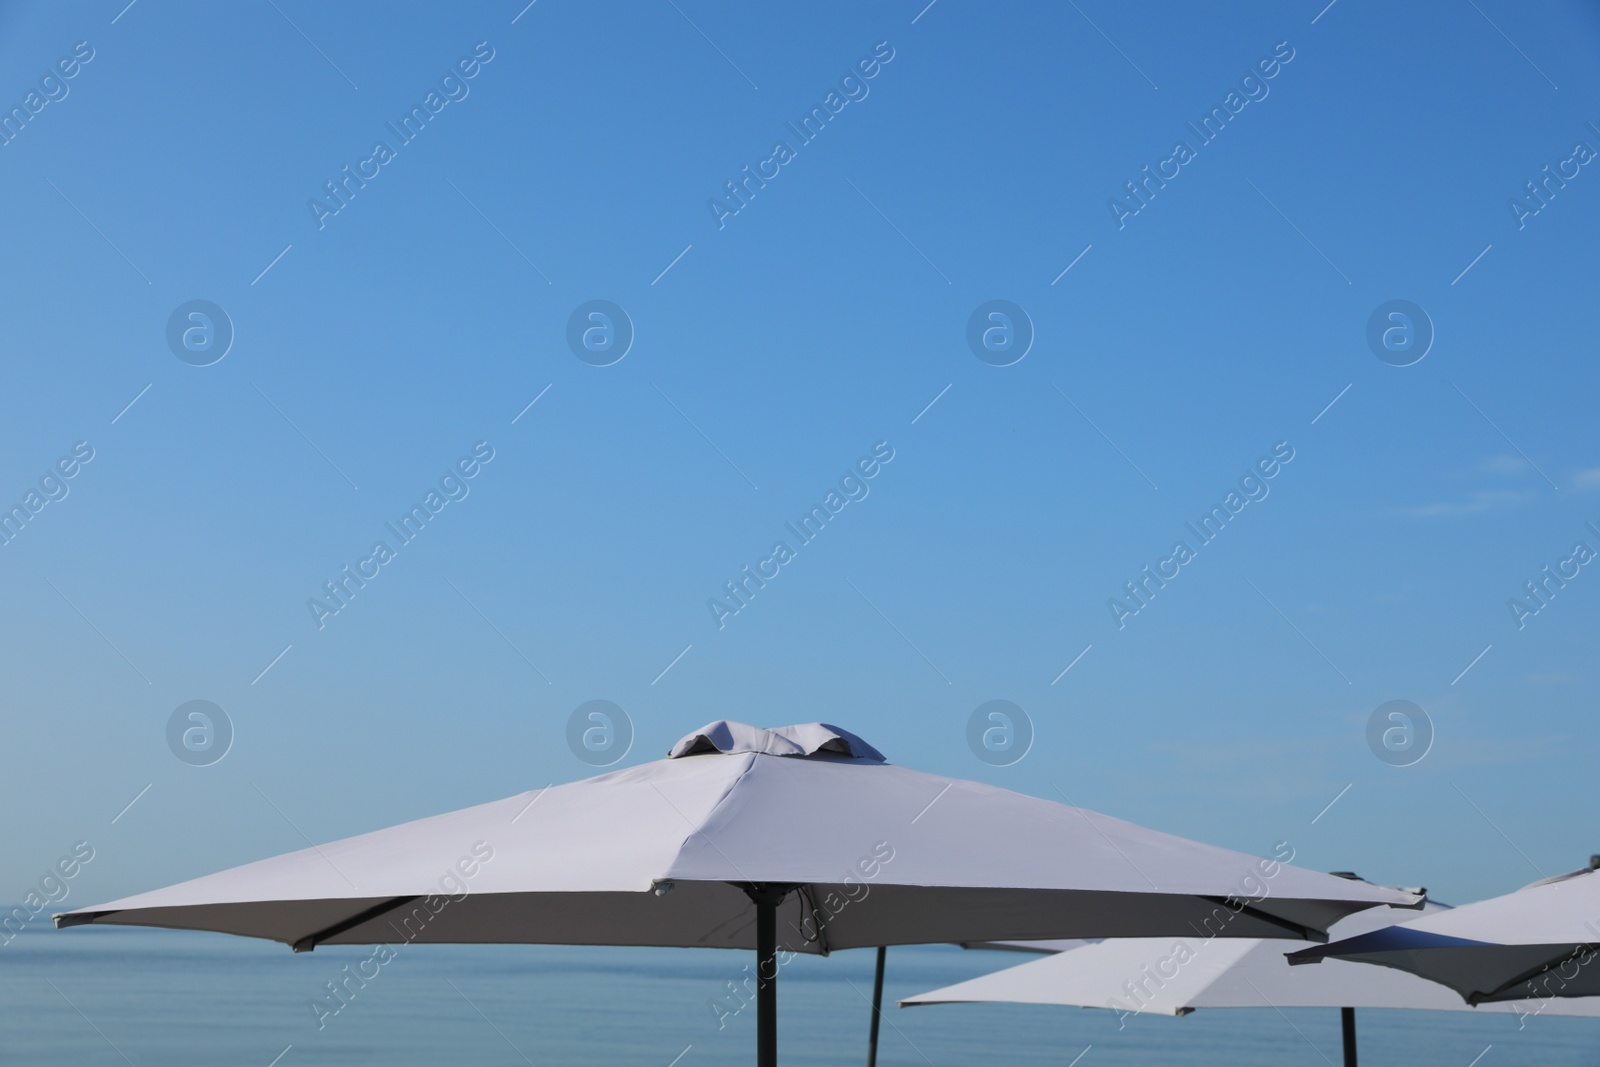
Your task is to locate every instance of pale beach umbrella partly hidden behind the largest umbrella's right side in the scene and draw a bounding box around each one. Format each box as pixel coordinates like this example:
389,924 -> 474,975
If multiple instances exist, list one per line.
899,876 -> 1600,1067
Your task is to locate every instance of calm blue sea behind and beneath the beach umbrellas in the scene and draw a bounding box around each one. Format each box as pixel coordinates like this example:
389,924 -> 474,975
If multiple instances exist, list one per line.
0,925 -> 1600,1067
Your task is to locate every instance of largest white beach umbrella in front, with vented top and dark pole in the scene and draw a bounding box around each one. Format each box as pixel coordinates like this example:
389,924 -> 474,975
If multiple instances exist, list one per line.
56,721 -> 1418,1067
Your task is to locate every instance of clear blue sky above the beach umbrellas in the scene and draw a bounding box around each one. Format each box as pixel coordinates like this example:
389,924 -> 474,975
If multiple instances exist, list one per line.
0,0 -> 1600,921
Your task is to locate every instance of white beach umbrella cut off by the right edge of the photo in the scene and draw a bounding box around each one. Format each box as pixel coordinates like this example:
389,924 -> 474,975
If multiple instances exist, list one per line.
1290,856 -> 1600,1011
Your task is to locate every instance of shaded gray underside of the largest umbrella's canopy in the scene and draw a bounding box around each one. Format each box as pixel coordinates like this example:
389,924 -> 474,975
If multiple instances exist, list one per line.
69,881 -> 1362,953
